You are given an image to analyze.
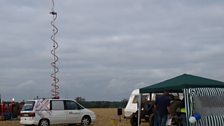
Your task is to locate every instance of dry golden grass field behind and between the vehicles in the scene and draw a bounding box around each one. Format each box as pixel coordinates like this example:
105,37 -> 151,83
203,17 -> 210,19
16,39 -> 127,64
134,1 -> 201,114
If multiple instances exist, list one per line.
0,108 -> 149,126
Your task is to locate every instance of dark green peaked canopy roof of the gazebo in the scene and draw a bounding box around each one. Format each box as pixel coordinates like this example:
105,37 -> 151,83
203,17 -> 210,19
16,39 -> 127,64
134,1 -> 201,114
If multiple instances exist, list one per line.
140,74 -> 224,93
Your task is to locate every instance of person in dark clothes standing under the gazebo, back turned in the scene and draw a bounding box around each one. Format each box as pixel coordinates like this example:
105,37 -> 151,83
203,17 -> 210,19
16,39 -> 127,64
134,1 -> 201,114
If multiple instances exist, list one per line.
154,91 -> 171,126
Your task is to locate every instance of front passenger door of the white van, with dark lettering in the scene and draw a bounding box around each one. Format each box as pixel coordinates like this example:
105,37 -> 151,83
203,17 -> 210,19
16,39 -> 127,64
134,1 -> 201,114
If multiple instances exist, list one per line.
64,100 -> 82,123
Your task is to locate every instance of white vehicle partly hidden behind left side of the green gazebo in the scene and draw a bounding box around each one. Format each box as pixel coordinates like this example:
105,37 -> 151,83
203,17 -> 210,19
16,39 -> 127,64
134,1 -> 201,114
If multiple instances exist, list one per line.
124,89 -> 154,118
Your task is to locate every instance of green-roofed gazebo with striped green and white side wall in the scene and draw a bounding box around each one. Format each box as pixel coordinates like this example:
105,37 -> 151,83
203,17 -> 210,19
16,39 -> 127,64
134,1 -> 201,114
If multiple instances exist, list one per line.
140,74 -> 224,126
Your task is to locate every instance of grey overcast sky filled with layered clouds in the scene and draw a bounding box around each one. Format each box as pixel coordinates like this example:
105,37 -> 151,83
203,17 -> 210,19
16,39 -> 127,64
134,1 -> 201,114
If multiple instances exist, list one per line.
0,0 -> 224,101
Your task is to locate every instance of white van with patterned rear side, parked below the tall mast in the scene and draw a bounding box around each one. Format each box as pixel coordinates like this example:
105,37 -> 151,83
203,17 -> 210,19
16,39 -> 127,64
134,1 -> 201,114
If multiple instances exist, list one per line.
20,99 -> 96,126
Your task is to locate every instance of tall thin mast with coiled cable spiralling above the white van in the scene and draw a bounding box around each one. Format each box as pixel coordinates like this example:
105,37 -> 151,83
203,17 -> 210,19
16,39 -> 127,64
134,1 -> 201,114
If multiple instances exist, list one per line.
50,0 -> 59,99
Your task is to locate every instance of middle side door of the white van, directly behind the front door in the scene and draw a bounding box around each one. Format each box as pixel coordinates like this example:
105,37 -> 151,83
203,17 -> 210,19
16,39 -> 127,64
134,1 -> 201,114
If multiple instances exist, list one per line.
49,100 -> 66,124
